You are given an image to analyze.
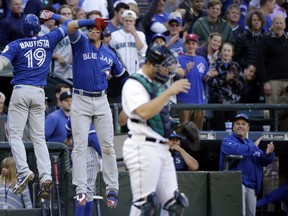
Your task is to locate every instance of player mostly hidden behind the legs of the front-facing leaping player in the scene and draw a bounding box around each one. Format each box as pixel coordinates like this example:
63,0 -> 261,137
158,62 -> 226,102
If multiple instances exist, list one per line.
66,119 -> 102,216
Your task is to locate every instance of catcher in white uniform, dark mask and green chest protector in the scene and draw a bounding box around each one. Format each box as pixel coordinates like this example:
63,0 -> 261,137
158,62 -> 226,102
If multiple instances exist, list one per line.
122,45 -> 190,216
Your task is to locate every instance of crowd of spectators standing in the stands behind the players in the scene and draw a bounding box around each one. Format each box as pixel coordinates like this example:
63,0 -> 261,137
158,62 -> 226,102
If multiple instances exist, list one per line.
0,0 -> 288,130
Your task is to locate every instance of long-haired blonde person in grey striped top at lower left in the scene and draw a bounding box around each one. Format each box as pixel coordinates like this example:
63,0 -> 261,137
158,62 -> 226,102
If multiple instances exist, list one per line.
0,157 -> 32,209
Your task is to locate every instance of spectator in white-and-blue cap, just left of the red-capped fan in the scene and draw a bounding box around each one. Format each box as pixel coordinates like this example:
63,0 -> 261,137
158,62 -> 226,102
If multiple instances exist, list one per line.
166,12 -> 184,57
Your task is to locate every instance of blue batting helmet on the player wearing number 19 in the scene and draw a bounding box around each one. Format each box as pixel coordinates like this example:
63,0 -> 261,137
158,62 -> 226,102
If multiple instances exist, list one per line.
23,14 -> 41,37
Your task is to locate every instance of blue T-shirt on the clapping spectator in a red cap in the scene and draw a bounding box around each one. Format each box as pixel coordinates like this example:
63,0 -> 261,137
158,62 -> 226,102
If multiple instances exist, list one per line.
177,55 -> 208,104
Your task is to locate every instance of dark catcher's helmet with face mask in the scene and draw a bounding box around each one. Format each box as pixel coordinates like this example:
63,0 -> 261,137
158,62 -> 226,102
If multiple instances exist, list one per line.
146,45 -> 178,83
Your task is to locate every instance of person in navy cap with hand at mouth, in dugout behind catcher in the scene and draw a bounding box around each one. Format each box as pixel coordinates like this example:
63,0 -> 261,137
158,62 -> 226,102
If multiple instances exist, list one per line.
168,131 -> 199,171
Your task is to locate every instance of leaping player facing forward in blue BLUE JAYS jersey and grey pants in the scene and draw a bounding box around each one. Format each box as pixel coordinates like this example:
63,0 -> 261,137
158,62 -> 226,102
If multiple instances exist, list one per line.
69,16 -> 128,208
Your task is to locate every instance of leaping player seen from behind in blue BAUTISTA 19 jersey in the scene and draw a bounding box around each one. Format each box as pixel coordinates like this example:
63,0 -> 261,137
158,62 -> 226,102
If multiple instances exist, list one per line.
0,11 -> 116,201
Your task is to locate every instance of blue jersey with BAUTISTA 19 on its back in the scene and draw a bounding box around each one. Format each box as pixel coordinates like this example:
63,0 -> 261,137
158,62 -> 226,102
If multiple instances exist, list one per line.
1,27 -> 67,86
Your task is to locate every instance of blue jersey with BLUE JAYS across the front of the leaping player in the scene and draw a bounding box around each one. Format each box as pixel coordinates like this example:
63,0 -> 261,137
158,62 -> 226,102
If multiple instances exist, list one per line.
69,31 -> 125,92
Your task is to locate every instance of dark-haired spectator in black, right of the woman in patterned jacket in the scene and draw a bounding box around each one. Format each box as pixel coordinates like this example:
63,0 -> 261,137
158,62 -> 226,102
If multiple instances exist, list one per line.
239,65 -> 264,103
